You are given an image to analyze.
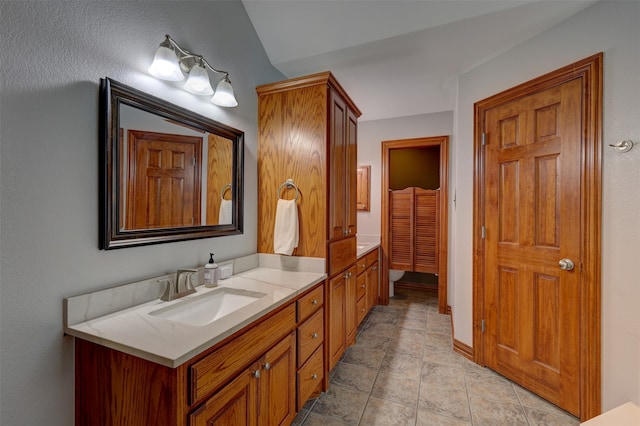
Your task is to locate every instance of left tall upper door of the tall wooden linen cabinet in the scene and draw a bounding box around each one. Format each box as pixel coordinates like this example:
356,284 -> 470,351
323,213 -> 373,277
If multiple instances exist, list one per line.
328,90 -> 348,240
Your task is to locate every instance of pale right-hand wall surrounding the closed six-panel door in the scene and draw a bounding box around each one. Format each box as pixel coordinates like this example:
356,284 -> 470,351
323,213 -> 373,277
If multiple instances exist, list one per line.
450,1 -> 640,410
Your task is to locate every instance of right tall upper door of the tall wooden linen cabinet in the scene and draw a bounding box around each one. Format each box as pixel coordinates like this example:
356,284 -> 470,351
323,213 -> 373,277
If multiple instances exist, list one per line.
344,109 -> 358,235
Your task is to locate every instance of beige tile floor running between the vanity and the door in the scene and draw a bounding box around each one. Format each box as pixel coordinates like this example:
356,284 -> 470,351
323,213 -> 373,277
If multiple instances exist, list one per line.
293,290 -> 579,426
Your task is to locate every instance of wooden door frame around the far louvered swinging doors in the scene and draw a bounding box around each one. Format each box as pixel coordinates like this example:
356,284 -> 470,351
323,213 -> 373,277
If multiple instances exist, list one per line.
380,136 -> 449,314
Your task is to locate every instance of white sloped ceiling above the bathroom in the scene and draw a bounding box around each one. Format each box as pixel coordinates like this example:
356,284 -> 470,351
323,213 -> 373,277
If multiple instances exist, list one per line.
242,0 -> 597,121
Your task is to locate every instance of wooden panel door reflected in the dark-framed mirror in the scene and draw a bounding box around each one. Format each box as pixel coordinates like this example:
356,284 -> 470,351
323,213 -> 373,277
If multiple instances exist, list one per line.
125,130 -> 202,229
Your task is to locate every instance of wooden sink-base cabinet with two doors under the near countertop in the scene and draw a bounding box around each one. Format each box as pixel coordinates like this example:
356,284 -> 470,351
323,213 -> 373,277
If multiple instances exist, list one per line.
75,301 -> 297,426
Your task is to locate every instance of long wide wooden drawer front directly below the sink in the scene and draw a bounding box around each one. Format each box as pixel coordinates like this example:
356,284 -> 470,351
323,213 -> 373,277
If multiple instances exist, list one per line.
189,303 -> 296,404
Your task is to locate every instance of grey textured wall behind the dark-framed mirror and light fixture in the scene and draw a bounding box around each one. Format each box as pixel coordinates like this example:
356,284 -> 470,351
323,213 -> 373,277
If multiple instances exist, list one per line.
0,0 -> 283,426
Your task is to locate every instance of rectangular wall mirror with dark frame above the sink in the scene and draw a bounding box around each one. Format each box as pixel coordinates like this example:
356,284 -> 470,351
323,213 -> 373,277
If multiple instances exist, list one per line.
100,78 -> 244,249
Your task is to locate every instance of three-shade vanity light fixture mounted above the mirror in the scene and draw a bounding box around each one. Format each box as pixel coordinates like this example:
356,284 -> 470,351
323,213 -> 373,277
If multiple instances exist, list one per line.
149,34 -> 238,107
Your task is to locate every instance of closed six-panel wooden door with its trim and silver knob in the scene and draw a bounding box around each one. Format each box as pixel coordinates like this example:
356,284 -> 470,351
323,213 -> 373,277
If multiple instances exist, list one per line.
473,54 -> 602,420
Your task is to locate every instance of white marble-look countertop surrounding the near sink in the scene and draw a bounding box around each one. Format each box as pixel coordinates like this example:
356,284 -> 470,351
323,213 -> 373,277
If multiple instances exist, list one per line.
65,266 -> 326,368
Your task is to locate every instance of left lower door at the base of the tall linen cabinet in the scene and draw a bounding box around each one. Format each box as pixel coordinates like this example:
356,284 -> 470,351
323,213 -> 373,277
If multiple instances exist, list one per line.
327,271 -> 347,371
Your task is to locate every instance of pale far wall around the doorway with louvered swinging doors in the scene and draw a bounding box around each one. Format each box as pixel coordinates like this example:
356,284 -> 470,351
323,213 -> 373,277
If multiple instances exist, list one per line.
358,111 -> 453,237
